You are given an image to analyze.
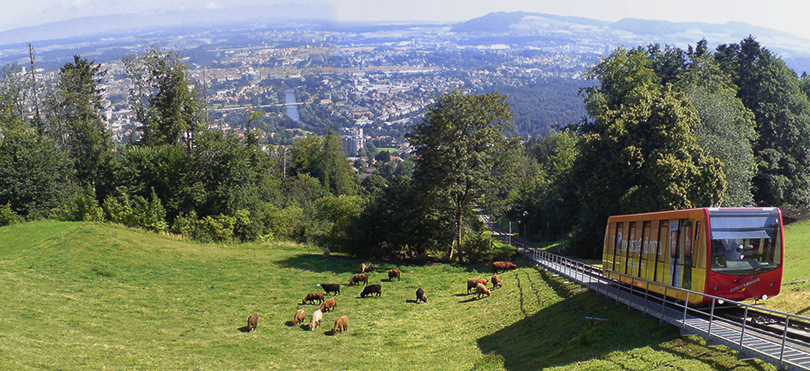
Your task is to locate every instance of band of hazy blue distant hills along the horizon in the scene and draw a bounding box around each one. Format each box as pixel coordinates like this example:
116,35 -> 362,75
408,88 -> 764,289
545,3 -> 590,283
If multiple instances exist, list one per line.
0,9 -> 810,73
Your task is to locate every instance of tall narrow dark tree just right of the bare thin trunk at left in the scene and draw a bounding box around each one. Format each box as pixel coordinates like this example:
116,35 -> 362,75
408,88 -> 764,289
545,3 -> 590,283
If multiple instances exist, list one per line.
49,55 -> 114,199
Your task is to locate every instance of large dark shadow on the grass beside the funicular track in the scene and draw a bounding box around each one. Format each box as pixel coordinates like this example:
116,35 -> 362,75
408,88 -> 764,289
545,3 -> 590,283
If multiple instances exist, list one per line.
469,272 -> 680,370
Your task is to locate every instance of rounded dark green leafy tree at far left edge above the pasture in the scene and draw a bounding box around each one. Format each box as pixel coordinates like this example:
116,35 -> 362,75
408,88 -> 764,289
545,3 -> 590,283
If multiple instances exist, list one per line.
0,129 -> 75,217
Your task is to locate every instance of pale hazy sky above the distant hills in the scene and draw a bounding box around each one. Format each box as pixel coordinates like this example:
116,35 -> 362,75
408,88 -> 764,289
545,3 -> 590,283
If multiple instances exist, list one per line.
0,0 -> 810,38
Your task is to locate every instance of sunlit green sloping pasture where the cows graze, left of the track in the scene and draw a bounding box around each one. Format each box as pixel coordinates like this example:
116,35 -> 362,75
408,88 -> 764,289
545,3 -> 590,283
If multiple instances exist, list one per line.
0,221 -> 773,370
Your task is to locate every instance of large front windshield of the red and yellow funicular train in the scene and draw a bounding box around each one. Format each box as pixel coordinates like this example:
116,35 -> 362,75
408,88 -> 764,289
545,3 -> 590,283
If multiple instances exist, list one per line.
709,209 -> 782,275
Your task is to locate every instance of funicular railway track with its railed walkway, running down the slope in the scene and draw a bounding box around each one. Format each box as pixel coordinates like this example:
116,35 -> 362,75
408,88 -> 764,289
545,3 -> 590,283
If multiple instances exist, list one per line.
481,215 -> 810,370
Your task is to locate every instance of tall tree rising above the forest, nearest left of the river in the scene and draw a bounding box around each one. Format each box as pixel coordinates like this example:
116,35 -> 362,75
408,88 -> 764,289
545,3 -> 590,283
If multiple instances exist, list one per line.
124,49 -> 204,148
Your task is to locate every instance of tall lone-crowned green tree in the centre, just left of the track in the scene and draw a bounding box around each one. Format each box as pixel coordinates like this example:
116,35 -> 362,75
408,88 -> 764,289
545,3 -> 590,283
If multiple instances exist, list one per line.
407,91 -> 512,259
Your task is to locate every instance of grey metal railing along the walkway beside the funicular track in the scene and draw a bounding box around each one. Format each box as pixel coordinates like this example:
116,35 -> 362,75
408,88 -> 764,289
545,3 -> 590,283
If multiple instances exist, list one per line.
513,241 -> 810,370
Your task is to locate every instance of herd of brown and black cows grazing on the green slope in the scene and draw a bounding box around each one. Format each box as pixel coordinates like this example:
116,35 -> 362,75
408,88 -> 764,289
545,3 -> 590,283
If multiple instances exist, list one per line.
243,262 -> 517,335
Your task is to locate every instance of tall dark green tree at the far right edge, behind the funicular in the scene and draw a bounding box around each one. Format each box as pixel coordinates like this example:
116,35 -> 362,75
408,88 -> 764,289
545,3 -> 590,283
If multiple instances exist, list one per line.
715,36 -> 810,206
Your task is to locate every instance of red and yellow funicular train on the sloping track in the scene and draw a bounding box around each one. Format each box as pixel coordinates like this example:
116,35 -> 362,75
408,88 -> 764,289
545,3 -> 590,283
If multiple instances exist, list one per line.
602,208 -> 785,305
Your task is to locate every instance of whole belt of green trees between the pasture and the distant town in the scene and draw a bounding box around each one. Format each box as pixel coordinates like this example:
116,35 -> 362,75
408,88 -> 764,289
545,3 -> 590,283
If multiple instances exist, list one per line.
0,37 -> 810,262
